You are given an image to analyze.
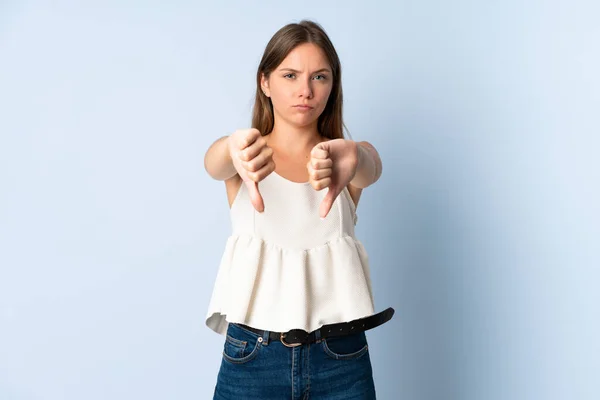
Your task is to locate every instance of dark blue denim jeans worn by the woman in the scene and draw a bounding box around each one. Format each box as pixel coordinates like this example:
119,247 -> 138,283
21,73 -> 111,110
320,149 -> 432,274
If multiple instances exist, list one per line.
213,323 -> 376,400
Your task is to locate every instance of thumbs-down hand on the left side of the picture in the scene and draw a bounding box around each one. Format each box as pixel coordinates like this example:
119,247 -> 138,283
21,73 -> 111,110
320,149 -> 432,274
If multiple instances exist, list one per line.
228,128 -> 275,212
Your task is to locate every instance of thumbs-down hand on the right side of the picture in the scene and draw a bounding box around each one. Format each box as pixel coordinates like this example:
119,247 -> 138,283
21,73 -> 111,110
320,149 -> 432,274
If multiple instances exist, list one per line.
306,139 -> 358,218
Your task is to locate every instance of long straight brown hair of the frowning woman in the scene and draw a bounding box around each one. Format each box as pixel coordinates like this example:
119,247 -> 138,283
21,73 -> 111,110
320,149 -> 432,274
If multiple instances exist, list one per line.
252,20 -> 345,139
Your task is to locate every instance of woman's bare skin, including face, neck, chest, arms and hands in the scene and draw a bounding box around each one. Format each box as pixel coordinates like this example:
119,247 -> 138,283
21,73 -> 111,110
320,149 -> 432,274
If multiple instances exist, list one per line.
204,44 -> 382,217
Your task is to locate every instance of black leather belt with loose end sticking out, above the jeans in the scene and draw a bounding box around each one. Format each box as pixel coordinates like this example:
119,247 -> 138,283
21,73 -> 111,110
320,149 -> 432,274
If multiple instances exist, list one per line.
237,307 -> 394,347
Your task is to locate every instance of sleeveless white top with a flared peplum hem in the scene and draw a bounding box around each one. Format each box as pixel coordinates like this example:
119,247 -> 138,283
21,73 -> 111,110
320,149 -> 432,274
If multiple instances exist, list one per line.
206,172 -> 375,335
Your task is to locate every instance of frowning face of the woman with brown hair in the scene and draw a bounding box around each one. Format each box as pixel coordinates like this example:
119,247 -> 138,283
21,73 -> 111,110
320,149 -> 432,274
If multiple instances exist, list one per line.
261,43 -> 333,131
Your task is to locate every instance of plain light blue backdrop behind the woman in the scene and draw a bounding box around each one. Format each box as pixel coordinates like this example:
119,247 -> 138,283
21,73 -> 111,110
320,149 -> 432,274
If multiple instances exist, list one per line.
0,0 -> 600,400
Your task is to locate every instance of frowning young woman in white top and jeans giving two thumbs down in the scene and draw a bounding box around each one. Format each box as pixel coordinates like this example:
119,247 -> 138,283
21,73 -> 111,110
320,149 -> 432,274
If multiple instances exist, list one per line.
204,21 -> 394,400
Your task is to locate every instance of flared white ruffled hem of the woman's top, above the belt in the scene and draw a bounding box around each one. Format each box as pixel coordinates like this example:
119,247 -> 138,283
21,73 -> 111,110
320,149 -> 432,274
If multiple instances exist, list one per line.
206,235 -> 375,335
